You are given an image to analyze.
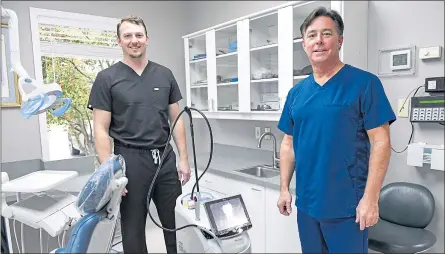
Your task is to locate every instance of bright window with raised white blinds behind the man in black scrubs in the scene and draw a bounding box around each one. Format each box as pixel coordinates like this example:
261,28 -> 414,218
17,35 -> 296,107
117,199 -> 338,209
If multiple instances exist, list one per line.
30,8 -> 122,163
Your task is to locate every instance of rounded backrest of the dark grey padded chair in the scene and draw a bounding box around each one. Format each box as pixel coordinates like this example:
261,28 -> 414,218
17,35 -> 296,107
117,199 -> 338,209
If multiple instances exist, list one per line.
379,182 -> 435,228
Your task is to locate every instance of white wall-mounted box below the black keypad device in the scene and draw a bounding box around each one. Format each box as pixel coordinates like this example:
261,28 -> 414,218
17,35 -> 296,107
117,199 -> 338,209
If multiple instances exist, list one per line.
406,142 -> 445,171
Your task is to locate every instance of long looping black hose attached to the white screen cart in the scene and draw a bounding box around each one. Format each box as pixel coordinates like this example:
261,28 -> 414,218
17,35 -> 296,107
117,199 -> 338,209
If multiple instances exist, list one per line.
147,106 -> 213,232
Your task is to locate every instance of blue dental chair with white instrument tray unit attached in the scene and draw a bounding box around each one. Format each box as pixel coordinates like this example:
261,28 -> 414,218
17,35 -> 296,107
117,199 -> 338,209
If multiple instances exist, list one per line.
2,155 -> 128,253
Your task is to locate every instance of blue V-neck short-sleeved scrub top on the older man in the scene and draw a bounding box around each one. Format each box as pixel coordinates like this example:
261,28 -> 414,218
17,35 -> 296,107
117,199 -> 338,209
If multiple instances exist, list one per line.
278,64 -> 396,218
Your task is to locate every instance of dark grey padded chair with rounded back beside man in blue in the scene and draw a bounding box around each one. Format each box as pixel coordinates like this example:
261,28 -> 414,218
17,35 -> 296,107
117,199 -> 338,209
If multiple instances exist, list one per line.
368,182 -> 436,253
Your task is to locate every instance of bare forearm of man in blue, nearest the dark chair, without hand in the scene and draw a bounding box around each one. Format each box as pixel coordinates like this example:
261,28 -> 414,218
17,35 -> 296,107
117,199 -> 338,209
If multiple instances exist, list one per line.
364,123 -> 391,202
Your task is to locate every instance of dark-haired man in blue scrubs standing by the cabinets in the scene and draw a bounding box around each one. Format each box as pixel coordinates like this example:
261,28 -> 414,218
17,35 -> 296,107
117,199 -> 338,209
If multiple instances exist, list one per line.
277,8 -> 396,253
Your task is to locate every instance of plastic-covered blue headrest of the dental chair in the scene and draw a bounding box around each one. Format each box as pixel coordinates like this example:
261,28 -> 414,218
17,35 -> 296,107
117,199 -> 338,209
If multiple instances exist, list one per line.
76,154 -> 125,215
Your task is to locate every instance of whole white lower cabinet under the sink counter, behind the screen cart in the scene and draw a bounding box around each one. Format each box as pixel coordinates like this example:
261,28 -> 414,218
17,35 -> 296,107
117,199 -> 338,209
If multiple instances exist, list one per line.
183,172 -> 301,253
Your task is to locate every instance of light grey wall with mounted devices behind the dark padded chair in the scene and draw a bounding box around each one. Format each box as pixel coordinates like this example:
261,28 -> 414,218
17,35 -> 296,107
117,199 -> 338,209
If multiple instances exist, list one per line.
368,1 -> 444,253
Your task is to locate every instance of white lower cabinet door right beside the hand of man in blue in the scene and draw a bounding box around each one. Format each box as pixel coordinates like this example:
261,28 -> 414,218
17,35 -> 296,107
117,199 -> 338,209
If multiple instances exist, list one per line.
265,188 -> 301,253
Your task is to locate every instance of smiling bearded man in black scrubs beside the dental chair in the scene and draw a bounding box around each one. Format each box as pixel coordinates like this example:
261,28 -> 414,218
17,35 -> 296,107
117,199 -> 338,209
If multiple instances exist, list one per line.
88,16 -> 190,253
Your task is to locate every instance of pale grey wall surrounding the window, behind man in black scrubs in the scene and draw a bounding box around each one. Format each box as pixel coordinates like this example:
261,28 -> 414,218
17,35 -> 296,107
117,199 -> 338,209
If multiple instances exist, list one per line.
1,1 -> 188,163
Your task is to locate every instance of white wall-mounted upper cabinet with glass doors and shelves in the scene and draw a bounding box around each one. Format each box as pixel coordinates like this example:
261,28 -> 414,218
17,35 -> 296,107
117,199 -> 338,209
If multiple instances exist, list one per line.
183,1 -> 368,121
